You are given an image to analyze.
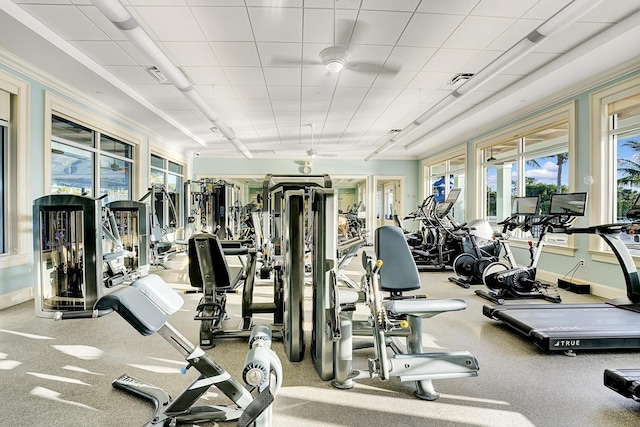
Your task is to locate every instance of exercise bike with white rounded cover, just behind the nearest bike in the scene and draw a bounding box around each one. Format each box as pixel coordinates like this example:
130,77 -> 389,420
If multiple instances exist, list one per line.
449,196 -> 539,289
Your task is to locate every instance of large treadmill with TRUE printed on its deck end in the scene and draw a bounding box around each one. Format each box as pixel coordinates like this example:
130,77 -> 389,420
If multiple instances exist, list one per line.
482,193 -> 640,356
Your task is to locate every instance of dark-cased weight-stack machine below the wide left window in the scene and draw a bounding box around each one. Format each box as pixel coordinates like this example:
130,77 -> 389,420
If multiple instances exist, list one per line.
33,194 -> 148,317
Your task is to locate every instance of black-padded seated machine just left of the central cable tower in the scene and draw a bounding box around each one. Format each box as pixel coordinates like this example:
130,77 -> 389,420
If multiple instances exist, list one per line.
189,233 -> 283,348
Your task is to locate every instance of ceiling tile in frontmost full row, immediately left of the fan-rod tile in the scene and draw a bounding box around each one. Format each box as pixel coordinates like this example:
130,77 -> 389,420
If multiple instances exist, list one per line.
248,7 -> 302,43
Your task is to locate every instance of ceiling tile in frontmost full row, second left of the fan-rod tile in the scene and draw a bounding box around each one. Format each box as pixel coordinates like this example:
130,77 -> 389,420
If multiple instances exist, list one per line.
192,7 -> 253,41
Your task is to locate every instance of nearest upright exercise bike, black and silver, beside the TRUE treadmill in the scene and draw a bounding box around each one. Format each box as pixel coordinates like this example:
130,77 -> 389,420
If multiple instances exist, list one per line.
476,193 -> 586,304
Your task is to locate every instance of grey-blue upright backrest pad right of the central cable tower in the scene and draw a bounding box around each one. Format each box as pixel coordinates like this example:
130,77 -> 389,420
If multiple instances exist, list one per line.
375,226 -> 420,292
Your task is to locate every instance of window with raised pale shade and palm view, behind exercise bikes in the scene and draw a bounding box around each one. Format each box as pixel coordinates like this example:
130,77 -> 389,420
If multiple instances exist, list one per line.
476,104 -> 575,246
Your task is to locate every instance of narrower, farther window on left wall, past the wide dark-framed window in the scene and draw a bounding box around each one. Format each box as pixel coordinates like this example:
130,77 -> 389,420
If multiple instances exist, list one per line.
149,154 -> 184,227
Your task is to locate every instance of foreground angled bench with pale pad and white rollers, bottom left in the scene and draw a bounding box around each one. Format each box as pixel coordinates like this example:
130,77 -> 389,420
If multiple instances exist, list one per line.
95,274 -> 282,427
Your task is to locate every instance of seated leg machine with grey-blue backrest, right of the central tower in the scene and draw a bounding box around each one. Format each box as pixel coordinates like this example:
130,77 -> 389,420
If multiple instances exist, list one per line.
331,226 -> 479,400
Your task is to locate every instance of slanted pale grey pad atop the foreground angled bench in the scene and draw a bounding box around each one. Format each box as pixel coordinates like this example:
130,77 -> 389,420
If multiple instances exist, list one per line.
95,286 -> 166,336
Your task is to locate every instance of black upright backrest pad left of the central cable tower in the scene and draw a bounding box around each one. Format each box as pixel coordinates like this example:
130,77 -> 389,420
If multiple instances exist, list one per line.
188,233 -> 231,288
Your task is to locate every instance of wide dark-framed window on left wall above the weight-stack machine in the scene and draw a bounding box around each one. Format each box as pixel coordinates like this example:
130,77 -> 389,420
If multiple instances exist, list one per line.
51,115 -> 133,201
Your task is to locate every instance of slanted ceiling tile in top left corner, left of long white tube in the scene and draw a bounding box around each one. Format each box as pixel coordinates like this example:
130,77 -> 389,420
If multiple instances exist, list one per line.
20,4 -> 107,41
